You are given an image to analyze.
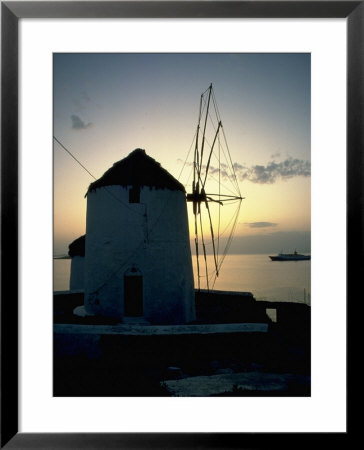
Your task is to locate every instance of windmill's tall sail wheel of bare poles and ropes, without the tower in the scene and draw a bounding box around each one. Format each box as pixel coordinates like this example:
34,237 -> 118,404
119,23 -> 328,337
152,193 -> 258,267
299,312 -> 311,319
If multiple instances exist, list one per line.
182,84 -> 243,290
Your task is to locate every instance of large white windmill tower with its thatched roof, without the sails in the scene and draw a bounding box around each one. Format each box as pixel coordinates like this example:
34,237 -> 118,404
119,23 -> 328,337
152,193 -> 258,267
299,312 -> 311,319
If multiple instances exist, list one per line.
85,149 -> 195,324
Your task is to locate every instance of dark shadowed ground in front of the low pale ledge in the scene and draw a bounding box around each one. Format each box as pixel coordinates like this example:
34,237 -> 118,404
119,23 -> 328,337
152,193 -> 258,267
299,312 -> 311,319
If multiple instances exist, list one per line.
54,324 -> 310,397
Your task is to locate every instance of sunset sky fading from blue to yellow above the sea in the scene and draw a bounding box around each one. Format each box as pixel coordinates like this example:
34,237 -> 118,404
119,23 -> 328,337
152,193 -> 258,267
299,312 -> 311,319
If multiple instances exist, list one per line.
54,53 -> 311,255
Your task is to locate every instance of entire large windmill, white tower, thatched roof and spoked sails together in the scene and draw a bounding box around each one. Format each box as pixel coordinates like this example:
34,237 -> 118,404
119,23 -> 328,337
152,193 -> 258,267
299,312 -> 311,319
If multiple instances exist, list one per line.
54,85 -> 243,318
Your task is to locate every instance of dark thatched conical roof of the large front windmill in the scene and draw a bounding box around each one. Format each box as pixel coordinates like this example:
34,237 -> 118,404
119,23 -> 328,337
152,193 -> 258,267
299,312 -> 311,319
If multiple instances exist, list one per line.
86,148 -> 185,195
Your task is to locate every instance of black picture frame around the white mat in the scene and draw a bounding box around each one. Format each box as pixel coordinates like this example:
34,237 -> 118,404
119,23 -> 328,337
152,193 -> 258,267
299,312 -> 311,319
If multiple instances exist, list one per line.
1,1 -> 358,449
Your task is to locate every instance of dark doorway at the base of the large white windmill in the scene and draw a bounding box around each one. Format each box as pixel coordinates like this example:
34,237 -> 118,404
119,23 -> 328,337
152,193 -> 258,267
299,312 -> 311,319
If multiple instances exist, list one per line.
124,269 -> 143,317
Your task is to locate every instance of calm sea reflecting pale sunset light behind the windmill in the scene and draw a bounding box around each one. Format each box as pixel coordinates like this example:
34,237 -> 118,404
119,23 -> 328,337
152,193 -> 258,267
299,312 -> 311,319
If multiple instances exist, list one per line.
53,254 -> 311,304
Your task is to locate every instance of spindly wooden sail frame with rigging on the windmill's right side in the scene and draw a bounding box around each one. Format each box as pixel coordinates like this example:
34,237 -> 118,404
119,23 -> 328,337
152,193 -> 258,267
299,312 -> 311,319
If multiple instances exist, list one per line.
186,84 -> 243,290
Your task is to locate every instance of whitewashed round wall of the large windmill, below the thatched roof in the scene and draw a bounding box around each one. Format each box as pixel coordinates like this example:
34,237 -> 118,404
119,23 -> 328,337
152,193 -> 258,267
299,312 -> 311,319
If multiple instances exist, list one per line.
85,186 -> 195,324
